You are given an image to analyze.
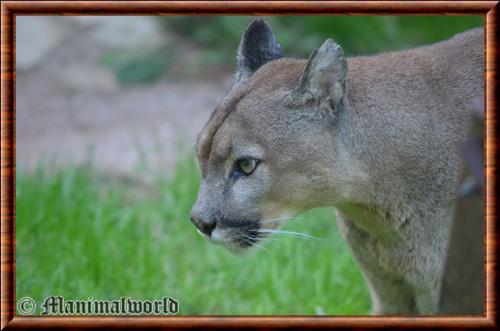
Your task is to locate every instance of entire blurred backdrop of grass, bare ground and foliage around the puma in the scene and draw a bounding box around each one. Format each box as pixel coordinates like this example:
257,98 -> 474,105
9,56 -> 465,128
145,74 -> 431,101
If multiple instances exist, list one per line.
16,16 -> 484,315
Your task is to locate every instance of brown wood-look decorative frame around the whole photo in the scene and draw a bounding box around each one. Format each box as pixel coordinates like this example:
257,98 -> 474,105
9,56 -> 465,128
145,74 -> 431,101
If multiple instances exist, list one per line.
1,1 -> 499,329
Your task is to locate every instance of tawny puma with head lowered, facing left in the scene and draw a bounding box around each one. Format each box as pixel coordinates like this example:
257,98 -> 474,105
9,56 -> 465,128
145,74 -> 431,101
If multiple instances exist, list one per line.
191,20 -> 484,315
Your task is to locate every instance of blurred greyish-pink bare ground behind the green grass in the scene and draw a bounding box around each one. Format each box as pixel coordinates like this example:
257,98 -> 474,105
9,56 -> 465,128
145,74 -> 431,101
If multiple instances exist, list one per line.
16,17 -> 231,180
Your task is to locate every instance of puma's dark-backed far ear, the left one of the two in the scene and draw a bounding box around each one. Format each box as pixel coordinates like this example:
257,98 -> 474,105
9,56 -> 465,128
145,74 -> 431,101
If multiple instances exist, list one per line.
235,20 -> 283,83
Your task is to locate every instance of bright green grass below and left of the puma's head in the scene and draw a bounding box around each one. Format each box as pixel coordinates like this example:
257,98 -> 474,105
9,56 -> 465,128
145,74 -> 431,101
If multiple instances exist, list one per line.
16,157 -> 369,315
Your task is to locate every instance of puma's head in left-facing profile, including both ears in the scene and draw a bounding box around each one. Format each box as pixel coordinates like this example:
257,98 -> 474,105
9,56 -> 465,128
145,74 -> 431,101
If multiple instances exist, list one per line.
191,20 -> 347,249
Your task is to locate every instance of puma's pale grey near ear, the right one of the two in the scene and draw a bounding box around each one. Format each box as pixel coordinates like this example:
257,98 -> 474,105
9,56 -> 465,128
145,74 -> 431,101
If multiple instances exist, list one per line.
295,39 -> 347,108
